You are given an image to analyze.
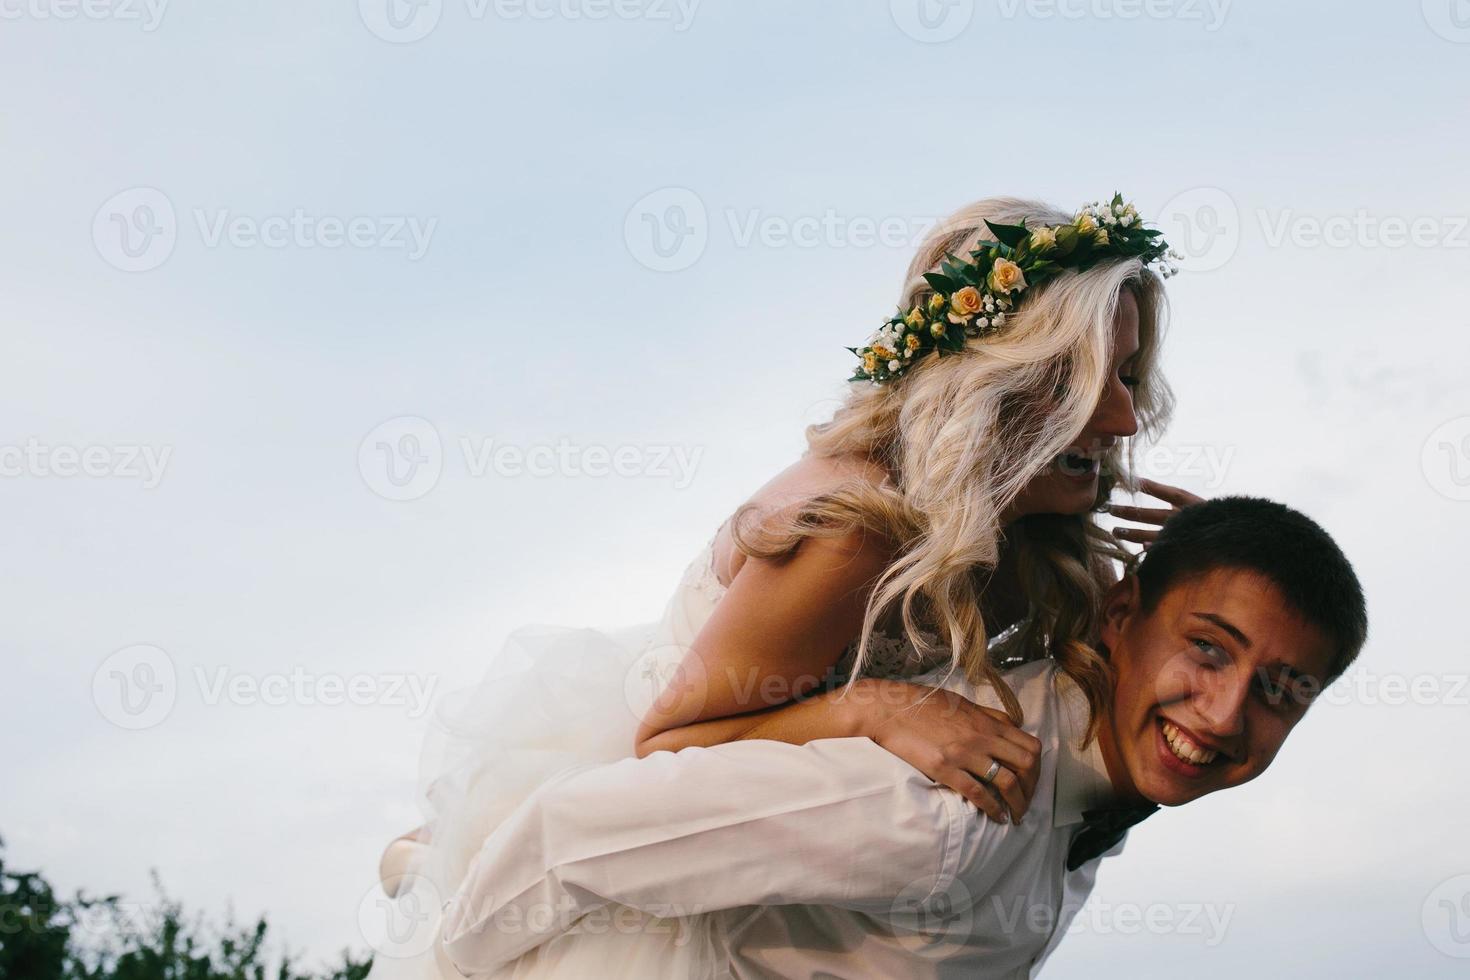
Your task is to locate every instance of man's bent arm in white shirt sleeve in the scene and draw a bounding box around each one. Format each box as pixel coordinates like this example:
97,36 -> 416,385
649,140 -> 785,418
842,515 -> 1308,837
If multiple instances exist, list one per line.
442,738 -> 976,976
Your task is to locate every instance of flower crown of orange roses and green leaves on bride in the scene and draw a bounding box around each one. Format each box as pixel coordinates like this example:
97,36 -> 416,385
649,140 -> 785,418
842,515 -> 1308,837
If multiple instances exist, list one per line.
847,194 -> 1182,385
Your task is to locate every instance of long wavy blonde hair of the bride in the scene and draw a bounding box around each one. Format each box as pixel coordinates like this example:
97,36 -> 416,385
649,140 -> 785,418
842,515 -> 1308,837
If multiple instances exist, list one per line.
731,197 -> 1173,739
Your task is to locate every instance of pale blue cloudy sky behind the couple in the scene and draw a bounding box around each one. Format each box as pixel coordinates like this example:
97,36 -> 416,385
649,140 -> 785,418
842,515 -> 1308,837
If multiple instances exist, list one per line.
0,0 -> 1470,979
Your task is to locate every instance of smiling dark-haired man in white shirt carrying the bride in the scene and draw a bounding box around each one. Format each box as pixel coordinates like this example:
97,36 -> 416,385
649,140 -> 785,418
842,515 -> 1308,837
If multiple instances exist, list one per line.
442,497 -> 1367,979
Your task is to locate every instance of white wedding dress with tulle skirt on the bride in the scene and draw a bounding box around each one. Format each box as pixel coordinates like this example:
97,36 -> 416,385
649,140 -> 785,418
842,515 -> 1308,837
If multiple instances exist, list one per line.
369,533 -> 964,980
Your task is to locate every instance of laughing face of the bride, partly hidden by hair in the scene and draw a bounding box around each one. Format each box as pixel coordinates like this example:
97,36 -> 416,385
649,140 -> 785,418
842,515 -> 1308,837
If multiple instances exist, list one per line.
1005,289 -> 1139,523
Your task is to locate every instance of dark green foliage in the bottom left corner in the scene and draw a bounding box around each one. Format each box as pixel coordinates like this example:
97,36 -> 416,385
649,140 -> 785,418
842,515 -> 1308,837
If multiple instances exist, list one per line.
0,842 -> 372,980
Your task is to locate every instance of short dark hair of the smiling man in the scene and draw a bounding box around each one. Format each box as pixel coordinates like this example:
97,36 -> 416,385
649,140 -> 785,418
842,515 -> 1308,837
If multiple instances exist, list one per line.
1135,497 -> 1369,685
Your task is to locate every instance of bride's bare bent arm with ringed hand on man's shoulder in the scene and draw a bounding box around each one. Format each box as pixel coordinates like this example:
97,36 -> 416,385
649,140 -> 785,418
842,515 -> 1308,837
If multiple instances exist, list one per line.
637,532 -> 1041,821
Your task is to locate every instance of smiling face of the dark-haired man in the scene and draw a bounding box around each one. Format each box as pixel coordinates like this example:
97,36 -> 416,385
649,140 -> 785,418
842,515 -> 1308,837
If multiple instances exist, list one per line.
1103,569 -> 1333,807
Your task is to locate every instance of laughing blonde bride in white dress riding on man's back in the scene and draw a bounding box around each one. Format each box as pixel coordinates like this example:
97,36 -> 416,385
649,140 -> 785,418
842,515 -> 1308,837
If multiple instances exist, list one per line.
361,197 -> 1198,980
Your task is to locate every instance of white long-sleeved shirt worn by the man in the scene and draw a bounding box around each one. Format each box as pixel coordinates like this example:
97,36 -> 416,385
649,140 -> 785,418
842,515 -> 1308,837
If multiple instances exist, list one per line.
442,660 -> 1122,980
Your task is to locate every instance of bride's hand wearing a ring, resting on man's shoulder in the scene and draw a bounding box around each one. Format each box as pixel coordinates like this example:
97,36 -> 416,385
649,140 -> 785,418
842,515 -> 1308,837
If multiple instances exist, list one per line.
858,680 -> 1041,823
